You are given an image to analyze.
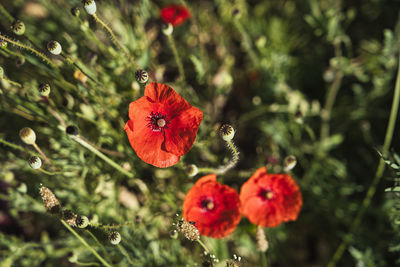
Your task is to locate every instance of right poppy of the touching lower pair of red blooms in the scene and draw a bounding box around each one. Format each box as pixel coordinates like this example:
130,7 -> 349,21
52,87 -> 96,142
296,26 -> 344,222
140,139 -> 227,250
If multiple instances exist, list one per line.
240,167 -> 303,227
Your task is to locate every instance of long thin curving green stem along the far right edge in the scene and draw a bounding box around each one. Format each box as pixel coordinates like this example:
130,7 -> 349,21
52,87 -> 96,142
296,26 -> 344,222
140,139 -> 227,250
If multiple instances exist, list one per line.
328,54 -> 400,267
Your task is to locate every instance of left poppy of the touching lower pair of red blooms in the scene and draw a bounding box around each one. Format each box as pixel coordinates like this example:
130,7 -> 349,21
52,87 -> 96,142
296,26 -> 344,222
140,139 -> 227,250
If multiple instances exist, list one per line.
183,174 -> 241,238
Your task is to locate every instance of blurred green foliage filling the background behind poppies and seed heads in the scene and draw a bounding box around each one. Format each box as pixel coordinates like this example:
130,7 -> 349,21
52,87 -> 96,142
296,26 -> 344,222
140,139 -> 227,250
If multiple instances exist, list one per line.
0,0 -> 400,266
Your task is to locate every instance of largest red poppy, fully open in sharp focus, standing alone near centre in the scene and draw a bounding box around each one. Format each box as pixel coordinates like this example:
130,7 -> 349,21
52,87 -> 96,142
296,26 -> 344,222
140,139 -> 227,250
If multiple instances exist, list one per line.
124,83 -> 203,168
